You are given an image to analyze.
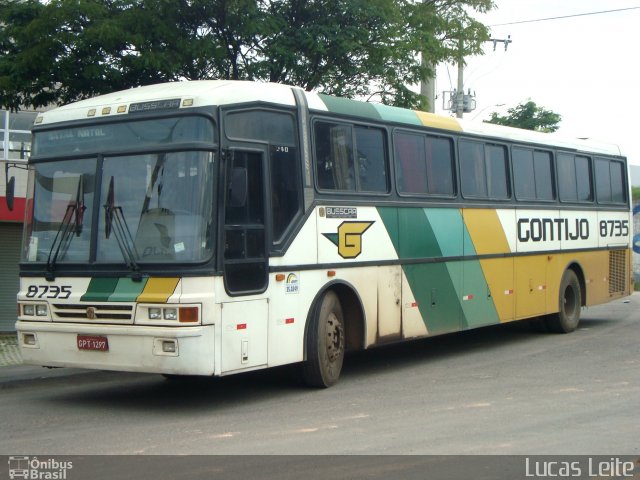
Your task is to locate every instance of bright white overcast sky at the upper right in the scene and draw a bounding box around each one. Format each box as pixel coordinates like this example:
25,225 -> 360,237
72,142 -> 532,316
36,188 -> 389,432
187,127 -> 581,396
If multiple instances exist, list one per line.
436,0 -> 640,165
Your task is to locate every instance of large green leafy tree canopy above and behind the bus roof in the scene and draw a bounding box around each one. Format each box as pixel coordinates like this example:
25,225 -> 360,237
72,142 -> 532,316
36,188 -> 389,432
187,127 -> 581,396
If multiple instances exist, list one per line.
0,0 -> 493,109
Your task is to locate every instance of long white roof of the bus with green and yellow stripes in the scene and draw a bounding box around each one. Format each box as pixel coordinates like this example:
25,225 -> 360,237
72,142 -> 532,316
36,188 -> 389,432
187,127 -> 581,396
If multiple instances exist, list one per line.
36,80 -> 621,155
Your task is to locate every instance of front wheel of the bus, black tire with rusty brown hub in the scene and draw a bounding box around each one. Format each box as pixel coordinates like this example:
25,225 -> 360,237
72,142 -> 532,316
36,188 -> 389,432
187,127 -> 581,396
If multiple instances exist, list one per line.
302,291 -> 345,388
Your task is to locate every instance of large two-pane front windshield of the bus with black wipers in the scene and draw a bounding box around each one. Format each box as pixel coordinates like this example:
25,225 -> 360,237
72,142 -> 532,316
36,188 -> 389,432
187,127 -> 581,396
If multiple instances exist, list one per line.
23,151 -> 214,266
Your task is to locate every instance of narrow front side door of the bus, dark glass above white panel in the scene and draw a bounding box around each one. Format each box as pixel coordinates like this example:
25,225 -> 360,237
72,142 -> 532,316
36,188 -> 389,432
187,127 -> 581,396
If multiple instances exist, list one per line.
221,149 -> 269,373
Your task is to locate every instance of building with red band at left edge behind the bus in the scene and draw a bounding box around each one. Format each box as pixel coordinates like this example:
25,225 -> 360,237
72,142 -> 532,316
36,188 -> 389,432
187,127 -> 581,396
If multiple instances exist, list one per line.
0,110 -> 37,332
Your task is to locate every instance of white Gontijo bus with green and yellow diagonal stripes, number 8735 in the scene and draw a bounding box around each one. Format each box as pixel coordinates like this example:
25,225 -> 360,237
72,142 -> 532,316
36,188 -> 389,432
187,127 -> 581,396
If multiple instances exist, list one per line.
16,80 -> 632,387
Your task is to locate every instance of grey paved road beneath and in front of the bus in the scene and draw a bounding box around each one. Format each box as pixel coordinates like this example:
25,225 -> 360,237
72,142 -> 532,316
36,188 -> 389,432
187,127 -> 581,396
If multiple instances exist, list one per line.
0,294 -> 640,455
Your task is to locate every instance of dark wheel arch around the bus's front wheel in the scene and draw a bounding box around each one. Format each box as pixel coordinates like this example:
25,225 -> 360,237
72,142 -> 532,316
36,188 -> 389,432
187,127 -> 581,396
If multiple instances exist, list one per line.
304,280 -> 366,360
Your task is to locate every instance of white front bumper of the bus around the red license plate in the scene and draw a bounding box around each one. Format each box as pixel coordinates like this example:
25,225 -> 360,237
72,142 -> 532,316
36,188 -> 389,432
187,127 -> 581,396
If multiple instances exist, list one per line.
16,321 -> 215,375
